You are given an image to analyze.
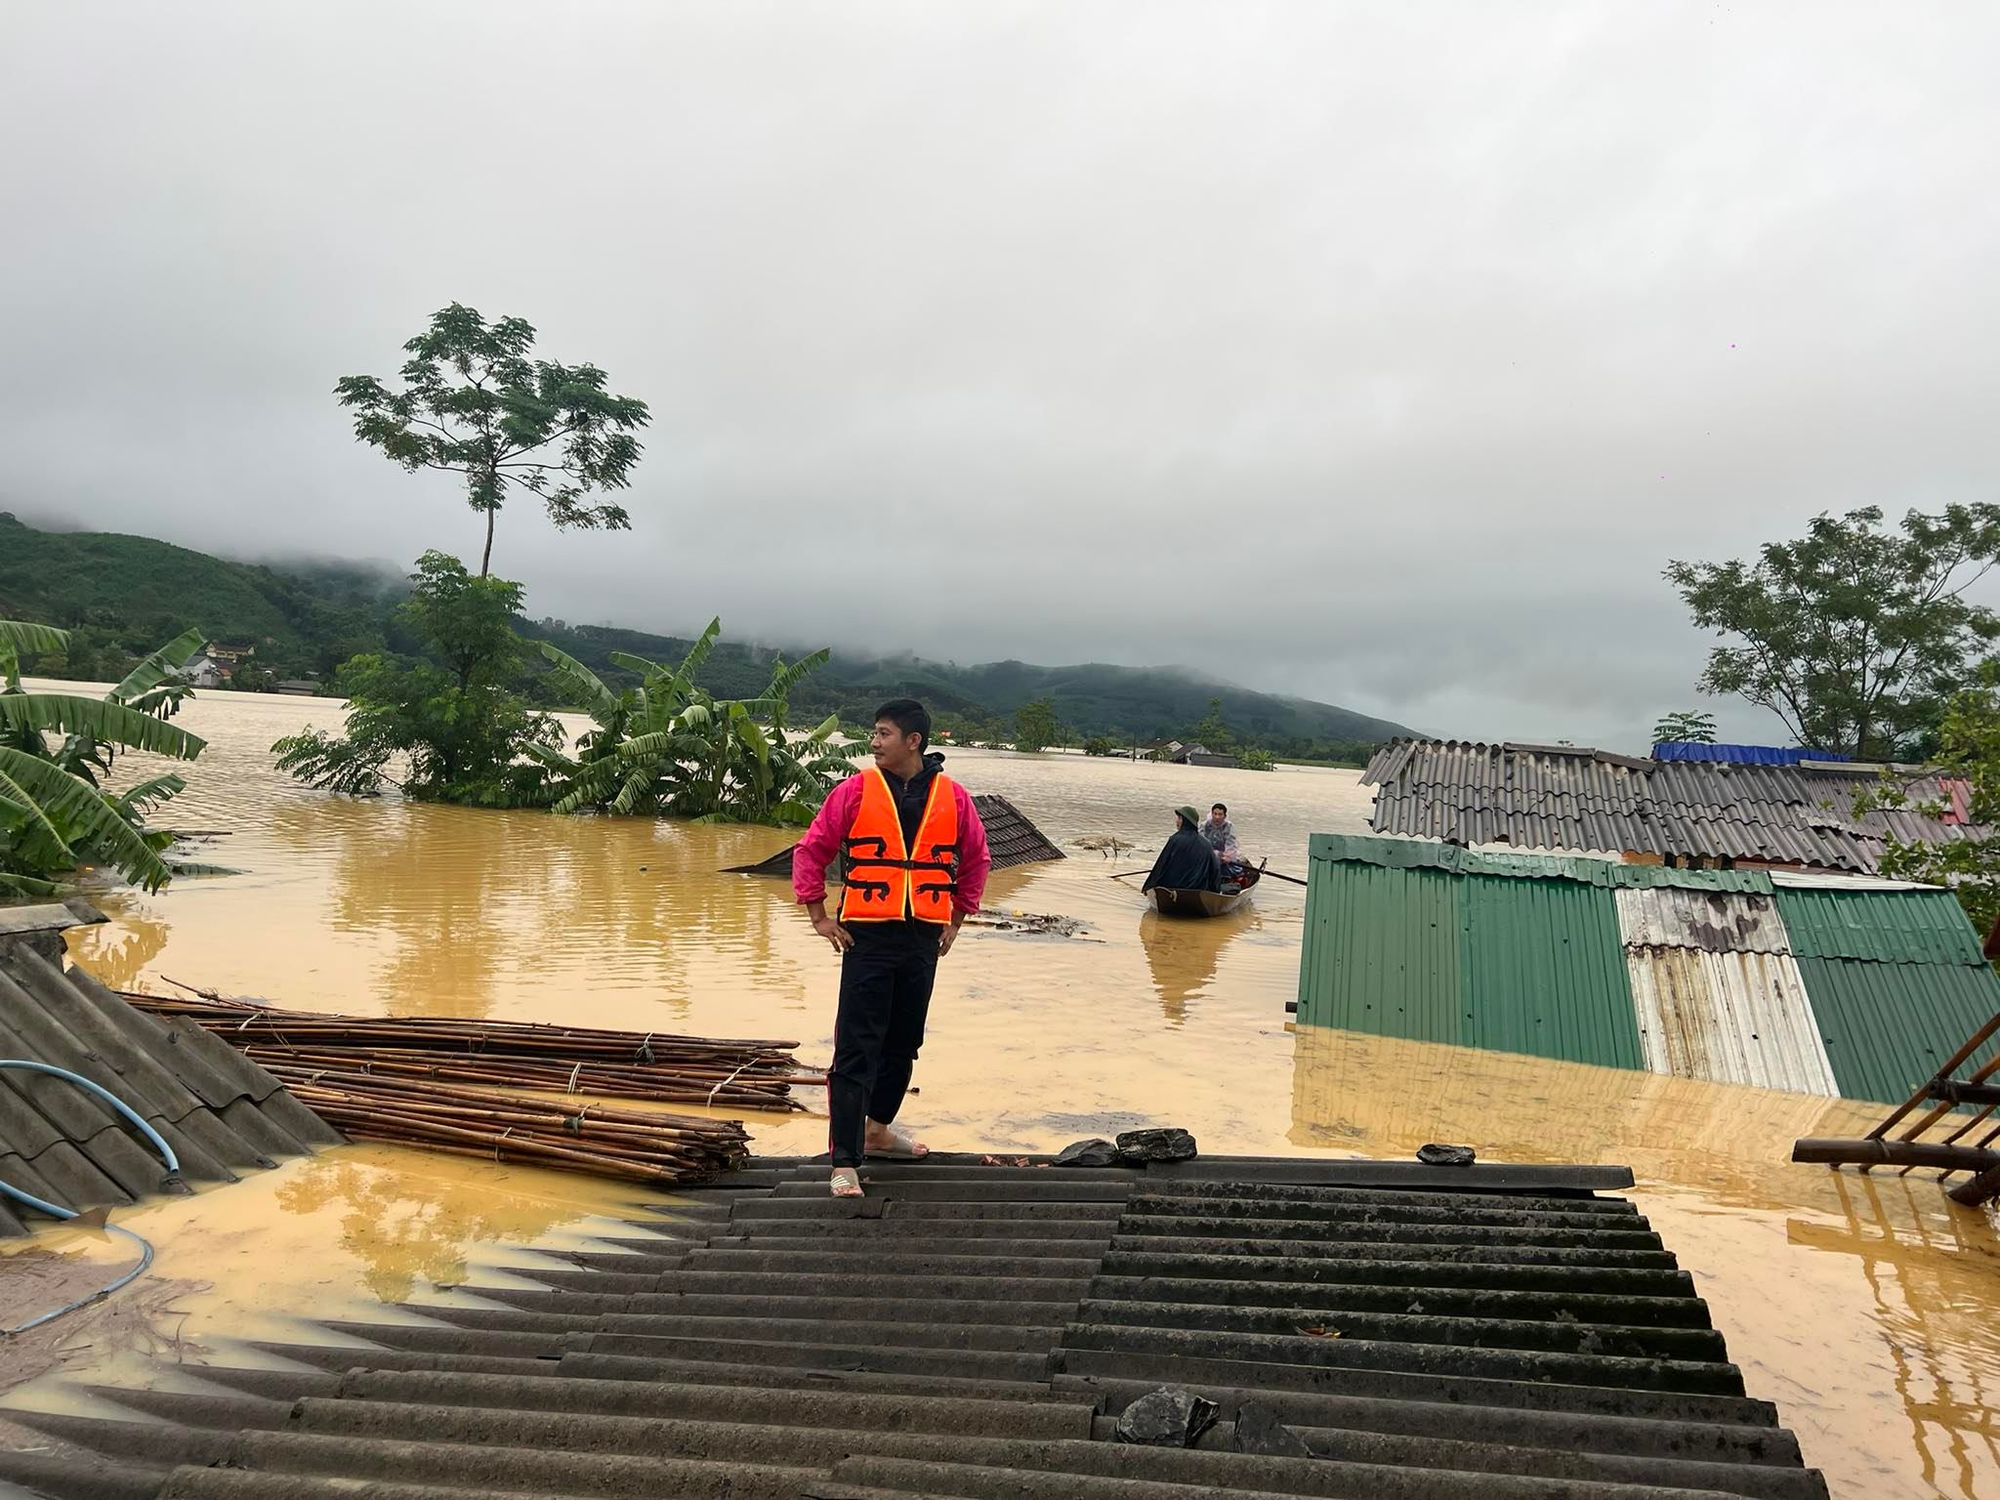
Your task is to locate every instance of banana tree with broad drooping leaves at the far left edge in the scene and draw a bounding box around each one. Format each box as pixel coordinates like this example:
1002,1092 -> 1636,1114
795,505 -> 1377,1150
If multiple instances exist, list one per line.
0,620 -> 204,894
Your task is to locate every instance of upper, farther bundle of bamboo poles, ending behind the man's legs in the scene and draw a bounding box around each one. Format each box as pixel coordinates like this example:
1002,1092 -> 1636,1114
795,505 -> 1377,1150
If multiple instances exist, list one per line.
122,990 -> 826,1110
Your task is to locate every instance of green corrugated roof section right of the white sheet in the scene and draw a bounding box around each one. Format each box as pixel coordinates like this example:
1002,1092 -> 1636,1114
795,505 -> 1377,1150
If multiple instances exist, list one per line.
1798,964 -> 2000,1104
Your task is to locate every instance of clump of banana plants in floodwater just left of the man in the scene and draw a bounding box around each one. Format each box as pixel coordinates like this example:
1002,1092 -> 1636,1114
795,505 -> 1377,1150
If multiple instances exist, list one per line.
532,620 -> 864,826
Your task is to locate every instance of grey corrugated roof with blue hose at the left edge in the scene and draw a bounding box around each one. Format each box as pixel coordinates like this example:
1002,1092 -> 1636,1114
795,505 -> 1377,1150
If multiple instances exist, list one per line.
0,942 -> 340,1234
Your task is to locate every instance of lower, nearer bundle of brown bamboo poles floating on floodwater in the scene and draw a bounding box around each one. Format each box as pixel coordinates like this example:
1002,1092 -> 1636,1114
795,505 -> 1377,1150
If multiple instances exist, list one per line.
264,1058 -> 750,1184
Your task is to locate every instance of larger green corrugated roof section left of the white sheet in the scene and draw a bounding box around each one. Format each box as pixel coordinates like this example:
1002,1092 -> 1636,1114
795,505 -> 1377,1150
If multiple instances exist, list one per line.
1298,840 -> 1644,1068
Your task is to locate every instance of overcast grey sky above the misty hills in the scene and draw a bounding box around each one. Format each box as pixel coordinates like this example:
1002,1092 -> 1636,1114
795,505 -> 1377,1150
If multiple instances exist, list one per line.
0,0 -> 2000,748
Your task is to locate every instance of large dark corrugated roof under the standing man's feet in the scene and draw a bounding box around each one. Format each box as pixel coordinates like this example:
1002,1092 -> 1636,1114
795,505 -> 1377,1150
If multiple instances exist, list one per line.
0,1158 -> 1826,1500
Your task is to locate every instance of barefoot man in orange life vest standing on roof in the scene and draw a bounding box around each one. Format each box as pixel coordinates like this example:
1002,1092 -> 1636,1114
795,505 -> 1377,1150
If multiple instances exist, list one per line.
792,698 -> 992,1198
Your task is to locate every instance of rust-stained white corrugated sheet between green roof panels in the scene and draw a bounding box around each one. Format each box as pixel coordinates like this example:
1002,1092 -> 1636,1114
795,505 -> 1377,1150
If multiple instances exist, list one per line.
1618,956 -> 1840,1098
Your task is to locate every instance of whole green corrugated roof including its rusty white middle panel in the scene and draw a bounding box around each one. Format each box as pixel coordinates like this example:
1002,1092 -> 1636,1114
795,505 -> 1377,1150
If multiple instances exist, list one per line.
1298,834 -> 2000,1102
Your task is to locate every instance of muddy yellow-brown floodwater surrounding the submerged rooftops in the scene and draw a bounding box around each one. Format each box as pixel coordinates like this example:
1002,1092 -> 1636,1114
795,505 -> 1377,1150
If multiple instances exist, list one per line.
11,694 -> 2000,1500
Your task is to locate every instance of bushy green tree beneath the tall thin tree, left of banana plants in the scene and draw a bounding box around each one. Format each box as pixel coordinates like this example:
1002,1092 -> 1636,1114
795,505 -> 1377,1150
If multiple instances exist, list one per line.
272,552 -> 562,808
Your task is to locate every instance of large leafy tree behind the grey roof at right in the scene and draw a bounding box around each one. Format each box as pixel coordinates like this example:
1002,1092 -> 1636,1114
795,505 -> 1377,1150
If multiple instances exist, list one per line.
1666,504 -> 2000,760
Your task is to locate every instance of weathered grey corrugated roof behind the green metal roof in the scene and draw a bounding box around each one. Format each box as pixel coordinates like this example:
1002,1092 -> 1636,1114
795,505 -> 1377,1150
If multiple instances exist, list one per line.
1362,740 -> 1992,874
